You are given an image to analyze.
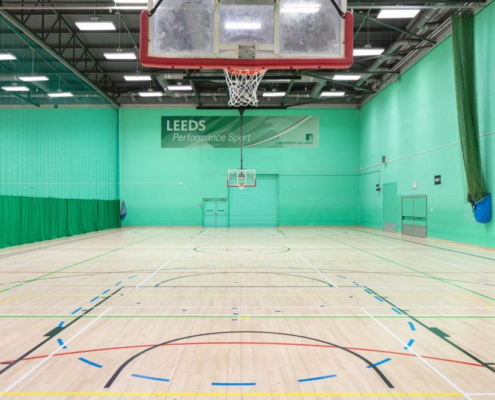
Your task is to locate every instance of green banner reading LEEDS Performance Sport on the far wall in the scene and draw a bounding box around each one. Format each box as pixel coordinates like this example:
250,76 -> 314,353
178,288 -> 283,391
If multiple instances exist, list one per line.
162,116 -> 320,149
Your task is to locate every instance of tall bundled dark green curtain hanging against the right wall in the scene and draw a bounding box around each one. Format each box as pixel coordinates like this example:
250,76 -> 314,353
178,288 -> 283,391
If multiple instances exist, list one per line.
451,10 -> 487,204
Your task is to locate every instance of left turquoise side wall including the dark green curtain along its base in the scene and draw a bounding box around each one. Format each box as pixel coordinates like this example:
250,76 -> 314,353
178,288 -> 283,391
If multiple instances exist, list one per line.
0,108 -> 120,248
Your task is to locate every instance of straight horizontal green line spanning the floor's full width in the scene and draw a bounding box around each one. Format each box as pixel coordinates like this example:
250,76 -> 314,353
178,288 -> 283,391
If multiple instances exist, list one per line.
0,314 -> 495,320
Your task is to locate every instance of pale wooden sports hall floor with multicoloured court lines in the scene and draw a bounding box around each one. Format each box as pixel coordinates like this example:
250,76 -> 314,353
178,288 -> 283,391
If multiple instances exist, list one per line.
0,227 -> 495,399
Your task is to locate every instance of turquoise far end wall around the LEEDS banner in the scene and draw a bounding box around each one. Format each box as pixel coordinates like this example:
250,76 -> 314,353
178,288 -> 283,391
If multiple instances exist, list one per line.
120,109 -> 359,225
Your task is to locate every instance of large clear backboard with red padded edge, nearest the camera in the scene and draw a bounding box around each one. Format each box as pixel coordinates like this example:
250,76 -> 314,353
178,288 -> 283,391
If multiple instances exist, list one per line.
140,0 -> 353,69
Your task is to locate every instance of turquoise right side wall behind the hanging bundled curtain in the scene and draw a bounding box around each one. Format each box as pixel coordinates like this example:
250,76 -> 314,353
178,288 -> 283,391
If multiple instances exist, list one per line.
359,3 -> 495,247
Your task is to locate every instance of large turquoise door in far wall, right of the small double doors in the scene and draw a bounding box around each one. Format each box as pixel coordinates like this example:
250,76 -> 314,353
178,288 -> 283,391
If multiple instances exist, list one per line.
229,175 -> 278,227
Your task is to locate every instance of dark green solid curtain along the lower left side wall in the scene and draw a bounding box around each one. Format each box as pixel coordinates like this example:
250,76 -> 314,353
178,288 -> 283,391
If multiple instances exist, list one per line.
0,196 -> 120,248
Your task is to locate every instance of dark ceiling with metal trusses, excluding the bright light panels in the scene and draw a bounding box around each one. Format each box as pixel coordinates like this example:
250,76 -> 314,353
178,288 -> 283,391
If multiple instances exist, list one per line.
0,0 -> 485,108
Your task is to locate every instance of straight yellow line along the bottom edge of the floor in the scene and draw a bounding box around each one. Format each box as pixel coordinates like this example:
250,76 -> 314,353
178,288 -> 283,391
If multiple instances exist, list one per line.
0,392 -> 464,397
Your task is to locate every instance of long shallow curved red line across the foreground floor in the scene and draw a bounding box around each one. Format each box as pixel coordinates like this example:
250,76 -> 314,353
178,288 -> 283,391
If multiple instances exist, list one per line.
0,342 -> 495,369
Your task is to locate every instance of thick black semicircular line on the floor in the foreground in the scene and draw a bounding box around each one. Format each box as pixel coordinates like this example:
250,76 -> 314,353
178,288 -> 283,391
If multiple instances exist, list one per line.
105,331 -> 394,389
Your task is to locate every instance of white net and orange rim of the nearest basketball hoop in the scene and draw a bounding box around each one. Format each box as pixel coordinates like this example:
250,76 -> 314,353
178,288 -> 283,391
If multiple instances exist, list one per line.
224,69 -> 266,107
